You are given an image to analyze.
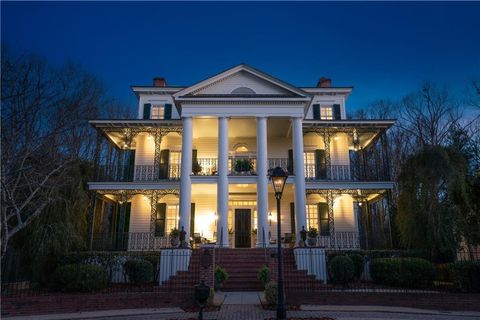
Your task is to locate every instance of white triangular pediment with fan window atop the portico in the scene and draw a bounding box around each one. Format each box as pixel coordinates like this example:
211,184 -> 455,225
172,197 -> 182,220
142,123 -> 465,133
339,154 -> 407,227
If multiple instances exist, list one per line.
175,64 -> 308,98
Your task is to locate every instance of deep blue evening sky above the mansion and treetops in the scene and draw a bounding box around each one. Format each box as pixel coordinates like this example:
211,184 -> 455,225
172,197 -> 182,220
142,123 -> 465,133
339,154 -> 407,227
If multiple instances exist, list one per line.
1,1 -> 480,110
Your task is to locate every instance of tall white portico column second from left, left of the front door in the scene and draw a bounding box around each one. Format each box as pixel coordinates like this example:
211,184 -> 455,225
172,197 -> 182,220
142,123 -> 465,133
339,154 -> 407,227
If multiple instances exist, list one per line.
217,117 -> 229,247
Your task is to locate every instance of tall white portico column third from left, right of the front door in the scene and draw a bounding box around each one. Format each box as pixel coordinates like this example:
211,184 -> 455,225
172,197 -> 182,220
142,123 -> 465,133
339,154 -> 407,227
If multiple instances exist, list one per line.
257,117 -> 269,247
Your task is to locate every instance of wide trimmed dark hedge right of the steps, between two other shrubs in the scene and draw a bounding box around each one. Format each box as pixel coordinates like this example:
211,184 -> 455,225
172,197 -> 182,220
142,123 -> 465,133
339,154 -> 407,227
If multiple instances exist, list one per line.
370,258 -> 435,288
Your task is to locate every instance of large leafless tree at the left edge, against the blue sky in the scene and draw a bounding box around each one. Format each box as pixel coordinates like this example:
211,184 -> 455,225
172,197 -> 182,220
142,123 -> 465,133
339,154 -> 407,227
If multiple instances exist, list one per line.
1,51 -> 104,255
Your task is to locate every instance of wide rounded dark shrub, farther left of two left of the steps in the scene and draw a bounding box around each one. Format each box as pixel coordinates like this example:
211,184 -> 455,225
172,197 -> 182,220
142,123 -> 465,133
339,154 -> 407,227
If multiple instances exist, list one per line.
54,264 -> 108,292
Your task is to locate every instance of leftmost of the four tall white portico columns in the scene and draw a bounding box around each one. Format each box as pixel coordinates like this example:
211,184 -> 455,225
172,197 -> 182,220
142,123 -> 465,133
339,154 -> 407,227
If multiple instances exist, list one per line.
179,117 -> 192,236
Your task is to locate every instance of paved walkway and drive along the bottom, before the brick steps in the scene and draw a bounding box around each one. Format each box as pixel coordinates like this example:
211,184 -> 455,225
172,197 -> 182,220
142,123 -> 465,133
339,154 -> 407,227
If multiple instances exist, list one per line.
5,292 -> 480,320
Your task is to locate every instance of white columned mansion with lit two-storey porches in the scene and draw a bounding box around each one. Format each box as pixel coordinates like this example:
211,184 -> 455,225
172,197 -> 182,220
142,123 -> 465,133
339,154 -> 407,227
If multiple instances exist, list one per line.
89,64 -> 394,250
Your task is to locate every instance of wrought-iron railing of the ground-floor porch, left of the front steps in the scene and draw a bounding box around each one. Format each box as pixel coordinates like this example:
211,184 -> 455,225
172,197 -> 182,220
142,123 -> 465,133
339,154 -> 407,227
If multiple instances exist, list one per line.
92,232 -> 171,251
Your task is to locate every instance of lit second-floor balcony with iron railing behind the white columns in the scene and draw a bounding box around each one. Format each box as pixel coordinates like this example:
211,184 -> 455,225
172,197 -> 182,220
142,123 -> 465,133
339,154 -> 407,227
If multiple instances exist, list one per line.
91,119 -> 393,182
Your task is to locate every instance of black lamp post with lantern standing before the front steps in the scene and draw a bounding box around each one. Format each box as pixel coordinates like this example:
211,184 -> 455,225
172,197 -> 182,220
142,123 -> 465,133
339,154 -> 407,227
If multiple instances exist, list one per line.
269,167 -> 288,320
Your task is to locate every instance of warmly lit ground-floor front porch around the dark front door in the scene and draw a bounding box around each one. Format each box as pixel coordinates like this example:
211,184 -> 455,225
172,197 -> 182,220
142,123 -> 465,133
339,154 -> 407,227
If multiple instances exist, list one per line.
91,183 -> 389,251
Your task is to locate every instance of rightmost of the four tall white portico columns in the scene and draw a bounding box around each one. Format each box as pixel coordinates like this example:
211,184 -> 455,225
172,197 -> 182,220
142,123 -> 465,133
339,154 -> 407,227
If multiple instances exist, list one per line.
292,118 -> 307,239
